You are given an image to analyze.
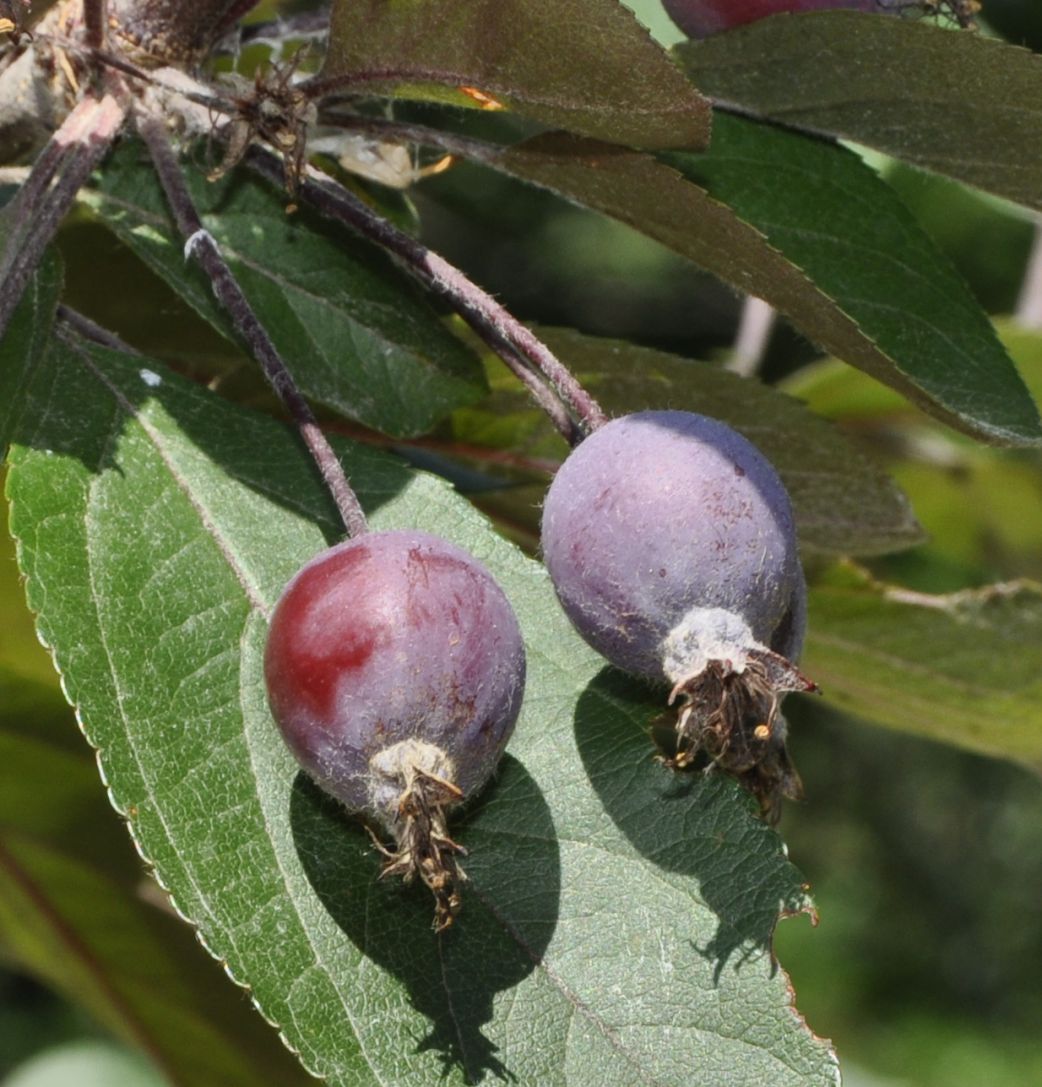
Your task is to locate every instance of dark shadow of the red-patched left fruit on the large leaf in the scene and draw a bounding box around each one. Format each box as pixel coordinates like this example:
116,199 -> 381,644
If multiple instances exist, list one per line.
290,755 -> 561,1083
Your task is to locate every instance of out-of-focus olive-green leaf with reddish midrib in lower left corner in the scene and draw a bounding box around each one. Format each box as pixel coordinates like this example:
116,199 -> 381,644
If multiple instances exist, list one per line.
0,495 -> 310,1087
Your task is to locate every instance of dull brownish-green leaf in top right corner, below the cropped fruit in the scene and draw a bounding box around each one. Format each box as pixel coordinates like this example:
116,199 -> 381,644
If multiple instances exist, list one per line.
676,11 -> 1042,209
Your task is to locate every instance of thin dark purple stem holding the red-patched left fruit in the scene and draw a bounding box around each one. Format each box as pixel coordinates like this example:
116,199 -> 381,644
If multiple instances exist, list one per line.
136,114 -> 368,537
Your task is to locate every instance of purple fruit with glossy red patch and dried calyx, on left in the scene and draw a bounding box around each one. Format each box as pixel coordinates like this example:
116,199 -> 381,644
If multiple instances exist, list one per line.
264,532 -> 525,930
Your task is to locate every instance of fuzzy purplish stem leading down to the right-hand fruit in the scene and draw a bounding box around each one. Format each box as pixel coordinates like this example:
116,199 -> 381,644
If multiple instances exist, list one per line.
246,147 -> 607,445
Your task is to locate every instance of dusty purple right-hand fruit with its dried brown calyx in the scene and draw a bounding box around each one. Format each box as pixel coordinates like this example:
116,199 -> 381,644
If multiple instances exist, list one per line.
542,411 -> 817,822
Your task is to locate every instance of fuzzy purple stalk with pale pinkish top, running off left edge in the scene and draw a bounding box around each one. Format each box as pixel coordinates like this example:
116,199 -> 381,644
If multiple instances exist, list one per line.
0,95 -> 126,335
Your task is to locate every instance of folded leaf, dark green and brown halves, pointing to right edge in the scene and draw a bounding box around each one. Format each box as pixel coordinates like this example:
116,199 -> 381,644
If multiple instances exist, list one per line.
482,116 -> 1042,445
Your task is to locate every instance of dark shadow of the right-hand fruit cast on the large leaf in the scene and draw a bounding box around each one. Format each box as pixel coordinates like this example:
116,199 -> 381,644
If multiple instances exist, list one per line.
575,667 -> 807,980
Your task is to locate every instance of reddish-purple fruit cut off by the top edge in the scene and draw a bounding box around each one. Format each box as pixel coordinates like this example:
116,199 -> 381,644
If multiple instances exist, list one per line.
663,0 -> 980,38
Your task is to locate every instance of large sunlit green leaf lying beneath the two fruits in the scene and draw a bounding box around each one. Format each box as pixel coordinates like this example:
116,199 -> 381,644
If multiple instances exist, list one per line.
9,332 -> 837,1087
